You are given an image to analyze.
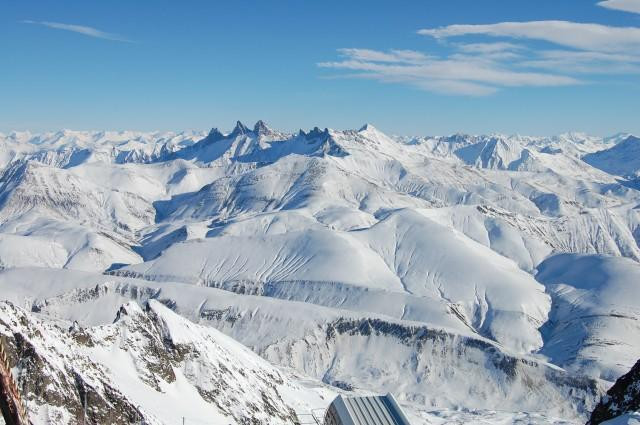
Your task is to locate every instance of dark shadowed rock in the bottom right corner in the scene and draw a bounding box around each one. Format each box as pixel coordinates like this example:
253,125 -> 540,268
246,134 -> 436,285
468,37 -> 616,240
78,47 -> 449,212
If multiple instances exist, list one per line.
588,361 -> 640,425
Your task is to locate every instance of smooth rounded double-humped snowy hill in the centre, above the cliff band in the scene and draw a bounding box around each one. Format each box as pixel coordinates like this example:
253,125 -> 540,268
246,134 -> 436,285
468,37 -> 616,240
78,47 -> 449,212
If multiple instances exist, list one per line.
123,210 -> 549,352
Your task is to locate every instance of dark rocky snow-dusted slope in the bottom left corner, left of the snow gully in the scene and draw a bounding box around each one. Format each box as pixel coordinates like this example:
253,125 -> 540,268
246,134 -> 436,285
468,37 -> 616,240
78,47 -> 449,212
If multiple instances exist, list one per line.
0,303 -> 141,424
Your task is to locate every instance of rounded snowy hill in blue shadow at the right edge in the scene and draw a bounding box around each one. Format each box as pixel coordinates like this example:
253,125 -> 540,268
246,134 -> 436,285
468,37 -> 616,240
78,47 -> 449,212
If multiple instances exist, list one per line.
536,254 -> 640,381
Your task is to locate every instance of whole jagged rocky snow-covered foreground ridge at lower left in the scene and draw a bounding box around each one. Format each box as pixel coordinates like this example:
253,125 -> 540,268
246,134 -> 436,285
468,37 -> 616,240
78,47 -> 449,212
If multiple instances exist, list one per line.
0,301 -> 330,425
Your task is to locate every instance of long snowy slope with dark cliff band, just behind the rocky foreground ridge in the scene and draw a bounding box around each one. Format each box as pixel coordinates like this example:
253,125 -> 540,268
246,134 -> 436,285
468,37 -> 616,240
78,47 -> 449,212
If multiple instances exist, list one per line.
0,269 -> 603,421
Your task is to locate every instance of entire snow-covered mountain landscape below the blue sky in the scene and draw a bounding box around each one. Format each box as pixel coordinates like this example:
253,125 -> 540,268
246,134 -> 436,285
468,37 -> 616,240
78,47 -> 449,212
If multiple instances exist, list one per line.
0,122 -> 640,423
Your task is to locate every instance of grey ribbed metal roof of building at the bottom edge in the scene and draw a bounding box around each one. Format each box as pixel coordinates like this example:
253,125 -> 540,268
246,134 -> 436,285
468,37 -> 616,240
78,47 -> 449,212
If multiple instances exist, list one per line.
324,394 -> 410,425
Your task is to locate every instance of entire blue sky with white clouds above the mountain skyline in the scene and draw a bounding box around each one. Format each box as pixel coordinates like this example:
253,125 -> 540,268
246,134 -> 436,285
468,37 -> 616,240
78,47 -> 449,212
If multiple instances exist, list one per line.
0,0 -> 640,135
